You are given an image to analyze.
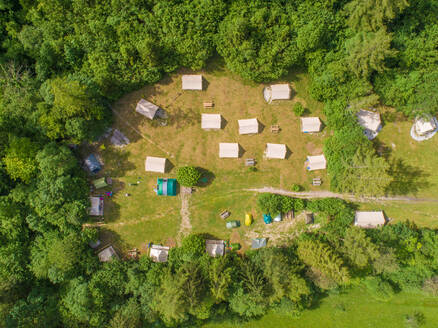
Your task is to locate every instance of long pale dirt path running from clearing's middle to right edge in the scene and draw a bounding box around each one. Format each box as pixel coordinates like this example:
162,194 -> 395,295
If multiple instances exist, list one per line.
244,187 -> 438,203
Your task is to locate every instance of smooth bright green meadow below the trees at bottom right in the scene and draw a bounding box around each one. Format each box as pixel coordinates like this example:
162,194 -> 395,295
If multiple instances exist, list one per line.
203,287 -> 438,328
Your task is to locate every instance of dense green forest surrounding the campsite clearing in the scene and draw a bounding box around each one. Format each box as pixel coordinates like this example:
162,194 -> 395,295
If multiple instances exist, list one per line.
0,0 -> 438,327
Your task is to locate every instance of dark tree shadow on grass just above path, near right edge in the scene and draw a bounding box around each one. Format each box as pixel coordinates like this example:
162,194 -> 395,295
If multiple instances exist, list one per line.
386,159 -> 431,195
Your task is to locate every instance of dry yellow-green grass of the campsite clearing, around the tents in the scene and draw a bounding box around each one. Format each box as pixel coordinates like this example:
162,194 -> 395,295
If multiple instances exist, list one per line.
88,61 -> 438,251
